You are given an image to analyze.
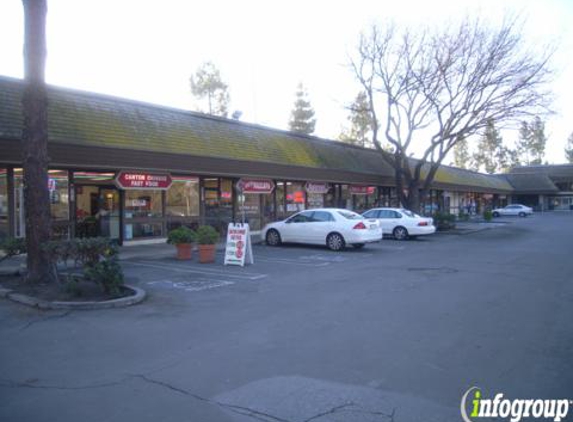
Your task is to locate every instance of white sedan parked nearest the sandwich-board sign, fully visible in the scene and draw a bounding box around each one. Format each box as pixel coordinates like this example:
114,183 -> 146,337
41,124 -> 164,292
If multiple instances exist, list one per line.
262,208 -> 382,251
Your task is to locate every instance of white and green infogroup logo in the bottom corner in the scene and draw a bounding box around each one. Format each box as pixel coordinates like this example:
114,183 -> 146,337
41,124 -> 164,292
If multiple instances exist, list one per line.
460,387 -> 573,422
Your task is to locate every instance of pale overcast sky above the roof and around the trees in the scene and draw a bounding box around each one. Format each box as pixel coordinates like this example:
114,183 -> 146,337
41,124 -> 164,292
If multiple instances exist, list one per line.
0,0 -> 573,163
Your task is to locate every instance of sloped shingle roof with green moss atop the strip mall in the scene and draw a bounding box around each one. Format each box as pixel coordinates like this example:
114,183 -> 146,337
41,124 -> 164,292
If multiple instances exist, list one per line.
0,77 -> 512,191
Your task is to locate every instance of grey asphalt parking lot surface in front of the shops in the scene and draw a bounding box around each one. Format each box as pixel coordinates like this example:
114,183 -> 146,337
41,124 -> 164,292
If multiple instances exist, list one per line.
0,213 -> 573,422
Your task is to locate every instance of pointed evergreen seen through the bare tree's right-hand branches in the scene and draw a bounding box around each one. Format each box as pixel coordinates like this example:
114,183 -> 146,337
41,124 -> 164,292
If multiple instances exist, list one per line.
473,119 -> 513,174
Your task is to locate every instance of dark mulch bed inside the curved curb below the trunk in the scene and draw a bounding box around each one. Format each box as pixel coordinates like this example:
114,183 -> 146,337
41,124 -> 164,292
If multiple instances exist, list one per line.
0,275 -> 133,302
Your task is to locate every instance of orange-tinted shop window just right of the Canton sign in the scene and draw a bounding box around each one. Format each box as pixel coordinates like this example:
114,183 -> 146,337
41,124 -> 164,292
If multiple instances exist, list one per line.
166,176 -> 200,217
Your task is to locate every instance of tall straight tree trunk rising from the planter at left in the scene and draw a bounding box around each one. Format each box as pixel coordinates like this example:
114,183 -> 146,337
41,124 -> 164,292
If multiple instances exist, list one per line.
22,0 -> 54,282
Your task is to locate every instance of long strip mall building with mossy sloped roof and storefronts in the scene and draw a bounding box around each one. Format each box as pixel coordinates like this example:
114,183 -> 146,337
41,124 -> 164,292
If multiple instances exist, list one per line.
0,77 -> 573,243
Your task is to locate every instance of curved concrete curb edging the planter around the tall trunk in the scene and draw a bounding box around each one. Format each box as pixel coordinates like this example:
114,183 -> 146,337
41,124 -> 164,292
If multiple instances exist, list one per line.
0,284 -> 147,310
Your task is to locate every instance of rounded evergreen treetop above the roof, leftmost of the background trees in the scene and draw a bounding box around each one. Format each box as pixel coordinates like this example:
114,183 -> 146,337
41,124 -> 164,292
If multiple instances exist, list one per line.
190,62 -> 230,117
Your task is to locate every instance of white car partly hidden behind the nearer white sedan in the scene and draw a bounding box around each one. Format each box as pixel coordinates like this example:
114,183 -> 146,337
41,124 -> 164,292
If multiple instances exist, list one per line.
362,208 -> 436,240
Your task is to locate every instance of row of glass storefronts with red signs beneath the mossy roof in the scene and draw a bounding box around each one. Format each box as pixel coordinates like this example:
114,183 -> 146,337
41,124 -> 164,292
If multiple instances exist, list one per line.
0,168 -> 396,244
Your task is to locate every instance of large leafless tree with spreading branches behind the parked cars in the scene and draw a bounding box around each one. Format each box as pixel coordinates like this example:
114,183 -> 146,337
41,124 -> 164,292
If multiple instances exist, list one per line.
350,18 -> 551,209
